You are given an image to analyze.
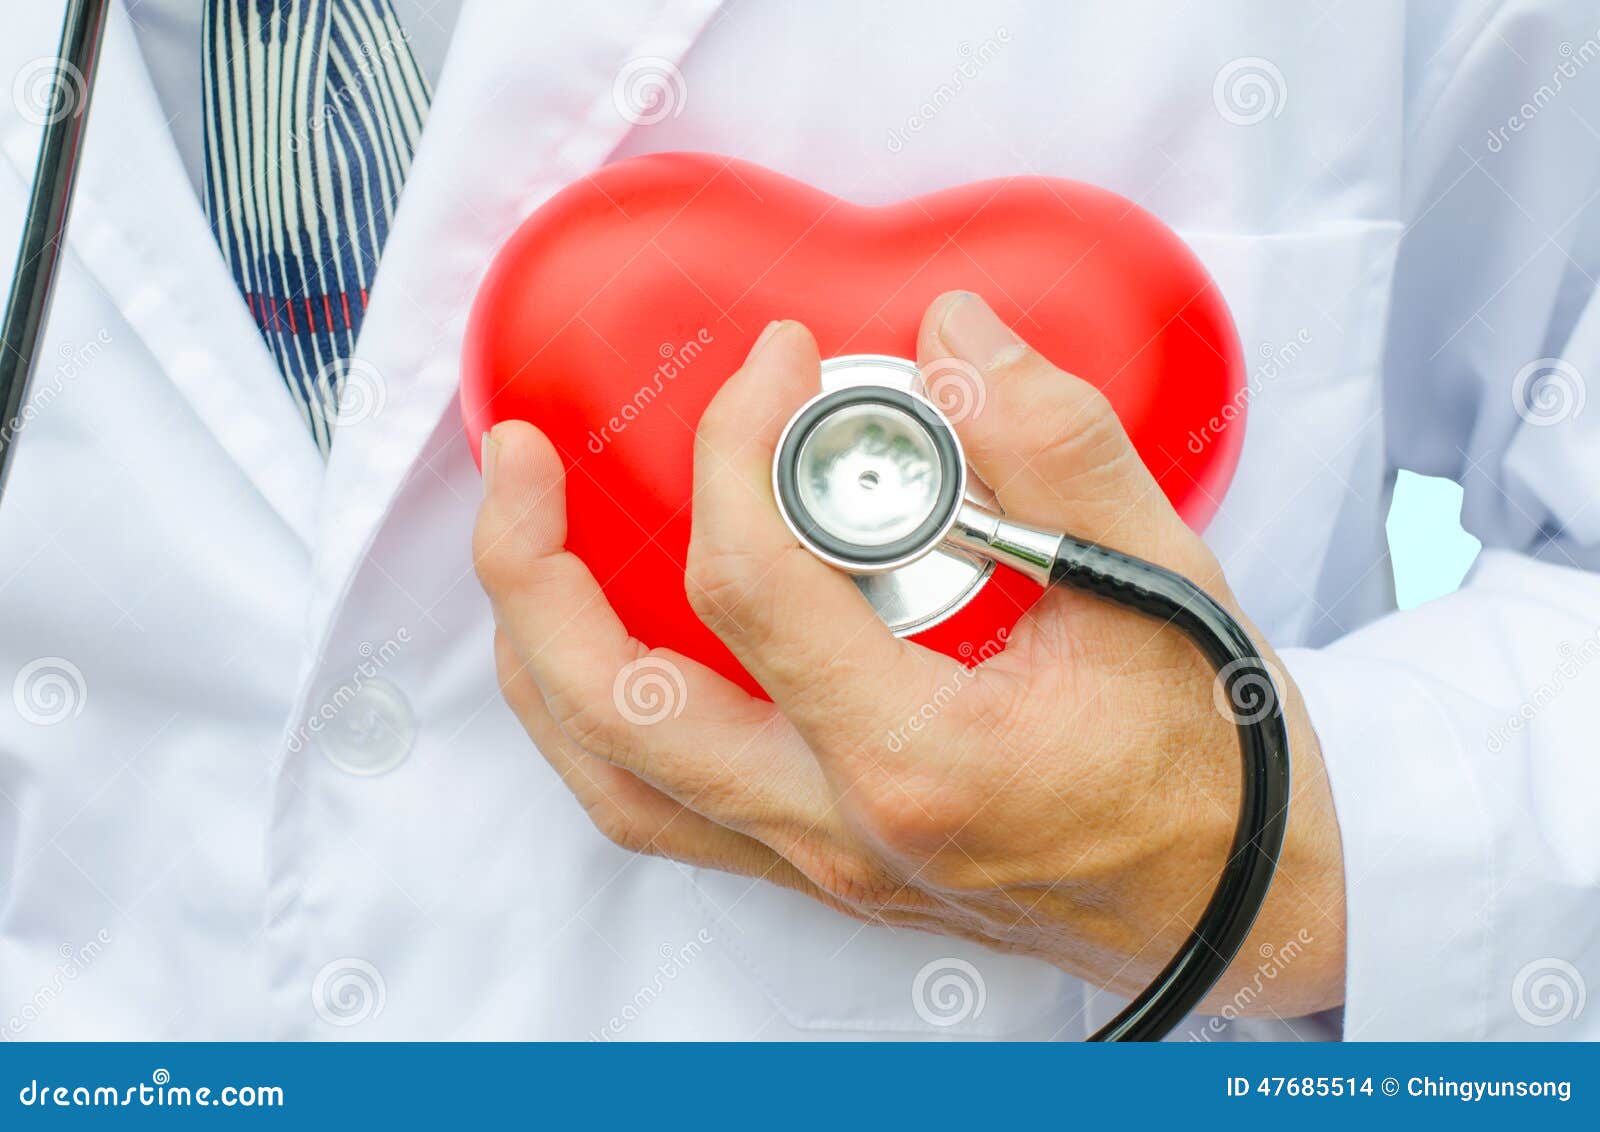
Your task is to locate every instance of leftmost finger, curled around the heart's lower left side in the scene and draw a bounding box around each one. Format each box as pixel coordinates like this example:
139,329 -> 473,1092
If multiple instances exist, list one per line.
474,422 -> 827,823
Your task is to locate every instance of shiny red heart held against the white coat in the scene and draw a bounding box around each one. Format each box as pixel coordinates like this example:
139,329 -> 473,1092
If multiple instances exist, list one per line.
461,153 -> 1243,691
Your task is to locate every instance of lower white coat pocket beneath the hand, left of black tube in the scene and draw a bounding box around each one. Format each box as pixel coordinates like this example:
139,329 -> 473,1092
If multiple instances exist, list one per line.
690,868 -> 1086,1041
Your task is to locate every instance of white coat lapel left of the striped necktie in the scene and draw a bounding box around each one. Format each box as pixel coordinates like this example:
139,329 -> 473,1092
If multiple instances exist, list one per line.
0,5 -> 323,544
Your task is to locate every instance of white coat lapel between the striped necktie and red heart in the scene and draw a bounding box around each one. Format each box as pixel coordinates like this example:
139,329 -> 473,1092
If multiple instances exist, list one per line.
312,0 -> 717,630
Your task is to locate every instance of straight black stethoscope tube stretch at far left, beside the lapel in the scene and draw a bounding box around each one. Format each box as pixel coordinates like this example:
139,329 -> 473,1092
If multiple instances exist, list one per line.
0,0 -> 107,496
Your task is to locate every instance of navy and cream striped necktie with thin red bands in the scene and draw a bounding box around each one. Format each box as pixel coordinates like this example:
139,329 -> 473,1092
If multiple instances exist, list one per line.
202,0 -> 429,456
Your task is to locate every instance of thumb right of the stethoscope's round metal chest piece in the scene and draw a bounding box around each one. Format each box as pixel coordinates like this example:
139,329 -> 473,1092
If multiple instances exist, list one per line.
917,291 -> 1194,561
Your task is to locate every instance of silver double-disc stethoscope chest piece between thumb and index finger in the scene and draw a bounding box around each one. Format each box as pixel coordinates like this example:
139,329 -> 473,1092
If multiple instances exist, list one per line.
773,353 -> 994,636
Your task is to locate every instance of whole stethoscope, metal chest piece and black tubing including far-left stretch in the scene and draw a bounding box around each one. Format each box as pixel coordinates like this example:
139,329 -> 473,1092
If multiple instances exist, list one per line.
0,0 -> 1290,1041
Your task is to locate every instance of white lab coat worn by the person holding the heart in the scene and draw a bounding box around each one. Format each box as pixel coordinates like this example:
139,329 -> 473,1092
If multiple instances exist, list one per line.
0,0 -> 1600,1039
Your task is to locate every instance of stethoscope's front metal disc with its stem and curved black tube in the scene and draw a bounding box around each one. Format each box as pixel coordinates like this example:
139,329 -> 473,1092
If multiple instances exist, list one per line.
773,364 -> 1290,1041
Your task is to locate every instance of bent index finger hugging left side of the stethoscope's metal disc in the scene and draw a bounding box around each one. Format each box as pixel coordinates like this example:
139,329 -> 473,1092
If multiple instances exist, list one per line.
686,321 -> 926,747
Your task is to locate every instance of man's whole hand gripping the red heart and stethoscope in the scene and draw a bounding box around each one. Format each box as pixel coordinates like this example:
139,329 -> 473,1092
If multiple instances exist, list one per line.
474,293 -> 1344,1015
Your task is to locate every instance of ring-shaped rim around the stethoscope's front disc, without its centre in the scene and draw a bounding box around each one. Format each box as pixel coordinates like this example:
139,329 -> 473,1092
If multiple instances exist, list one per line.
773,385 -> 966,574
